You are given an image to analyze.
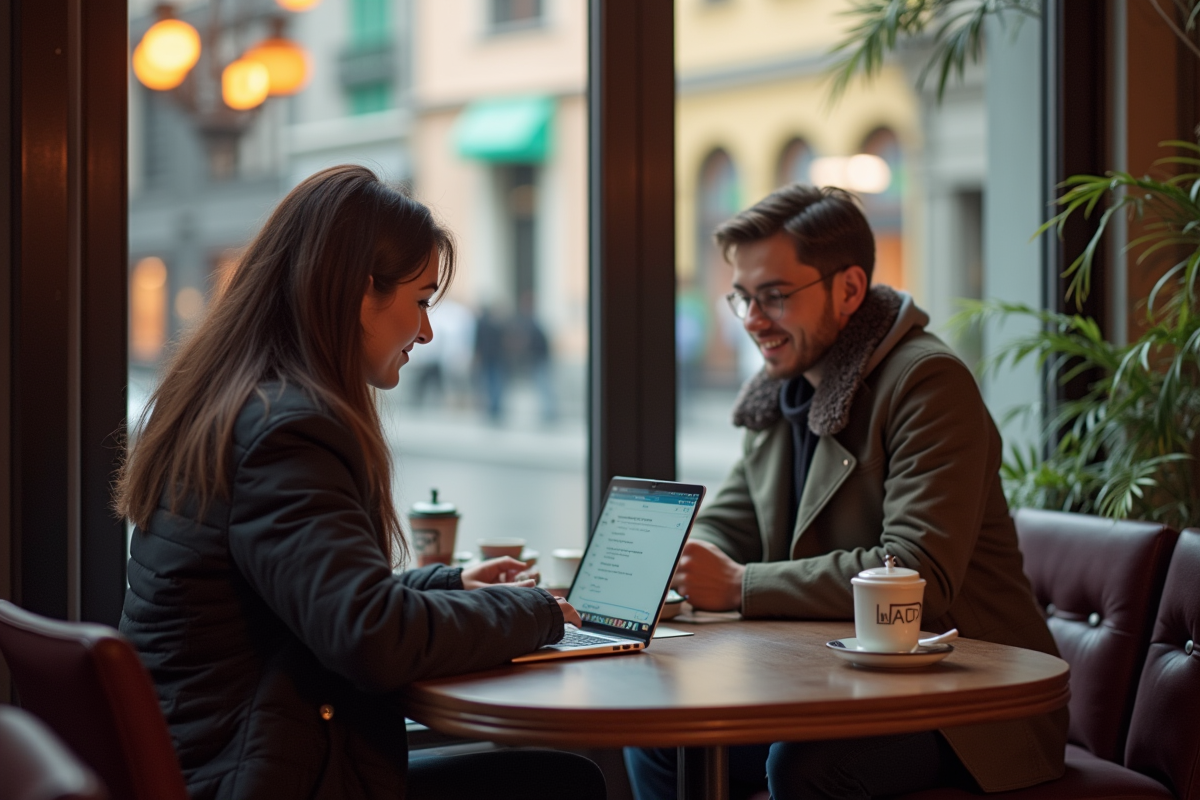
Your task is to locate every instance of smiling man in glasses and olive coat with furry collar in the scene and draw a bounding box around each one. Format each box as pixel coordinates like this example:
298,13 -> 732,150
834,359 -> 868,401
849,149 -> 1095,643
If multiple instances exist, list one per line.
626,184 -> 1067,800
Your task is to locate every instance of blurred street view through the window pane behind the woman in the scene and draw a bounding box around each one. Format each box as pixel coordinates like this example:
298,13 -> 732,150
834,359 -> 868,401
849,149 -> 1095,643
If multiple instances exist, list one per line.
130,0 -> 588,573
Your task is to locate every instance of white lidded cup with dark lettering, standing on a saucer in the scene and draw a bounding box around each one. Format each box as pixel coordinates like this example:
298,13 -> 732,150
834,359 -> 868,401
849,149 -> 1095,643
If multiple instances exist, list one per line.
850,555 -> 925,652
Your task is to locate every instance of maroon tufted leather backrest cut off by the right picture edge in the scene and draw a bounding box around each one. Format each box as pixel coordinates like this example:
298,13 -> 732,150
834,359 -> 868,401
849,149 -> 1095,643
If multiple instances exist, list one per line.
1126,528 -> 1200,800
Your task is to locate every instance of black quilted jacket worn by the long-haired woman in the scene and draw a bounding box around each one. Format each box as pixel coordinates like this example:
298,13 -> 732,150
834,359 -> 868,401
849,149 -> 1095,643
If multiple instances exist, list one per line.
121,385 -> 563,800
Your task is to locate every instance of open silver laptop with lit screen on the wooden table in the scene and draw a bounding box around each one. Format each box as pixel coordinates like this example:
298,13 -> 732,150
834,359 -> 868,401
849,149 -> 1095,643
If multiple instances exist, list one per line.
512,477 -> 704,663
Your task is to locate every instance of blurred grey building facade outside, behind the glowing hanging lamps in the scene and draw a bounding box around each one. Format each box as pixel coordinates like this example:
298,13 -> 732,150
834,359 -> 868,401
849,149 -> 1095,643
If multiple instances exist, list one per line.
128,0 -> 412,383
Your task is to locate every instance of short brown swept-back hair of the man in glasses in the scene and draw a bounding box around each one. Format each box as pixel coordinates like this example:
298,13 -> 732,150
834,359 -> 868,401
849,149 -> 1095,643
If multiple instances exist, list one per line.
713,184 -> 875,282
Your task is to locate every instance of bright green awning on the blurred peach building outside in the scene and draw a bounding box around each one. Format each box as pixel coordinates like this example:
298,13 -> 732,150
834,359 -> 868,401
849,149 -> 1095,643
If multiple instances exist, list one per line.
454,97 -> 554,164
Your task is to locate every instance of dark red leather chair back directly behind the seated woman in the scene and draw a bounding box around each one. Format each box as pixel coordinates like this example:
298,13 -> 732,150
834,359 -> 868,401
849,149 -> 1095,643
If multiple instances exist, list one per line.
0,600 -> 187,800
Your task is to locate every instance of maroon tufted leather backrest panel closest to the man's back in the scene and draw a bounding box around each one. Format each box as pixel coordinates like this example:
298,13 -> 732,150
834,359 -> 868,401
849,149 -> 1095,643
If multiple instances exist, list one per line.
1015,509 -> 1177,763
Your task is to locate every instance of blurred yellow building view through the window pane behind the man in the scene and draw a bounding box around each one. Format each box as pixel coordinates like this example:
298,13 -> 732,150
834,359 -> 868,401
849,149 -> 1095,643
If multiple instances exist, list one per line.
676,0 -> 985,488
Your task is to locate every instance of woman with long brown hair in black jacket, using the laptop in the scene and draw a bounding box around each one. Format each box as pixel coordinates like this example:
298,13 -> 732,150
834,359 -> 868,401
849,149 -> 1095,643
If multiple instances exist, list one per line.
115,167 -> 604,800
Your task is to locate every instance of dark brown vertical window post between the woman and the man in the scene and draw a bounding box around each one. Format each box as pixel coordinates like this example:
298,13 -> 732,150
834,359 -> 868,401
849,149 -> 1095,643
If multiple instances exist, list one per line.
588,0 -> 676,530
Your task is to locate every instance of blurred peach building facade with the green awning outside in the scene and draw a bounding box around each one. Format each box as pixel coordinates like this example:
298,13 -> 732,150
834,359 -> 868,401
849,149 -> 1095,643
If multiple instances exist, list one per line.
413,0 -> 588,427
